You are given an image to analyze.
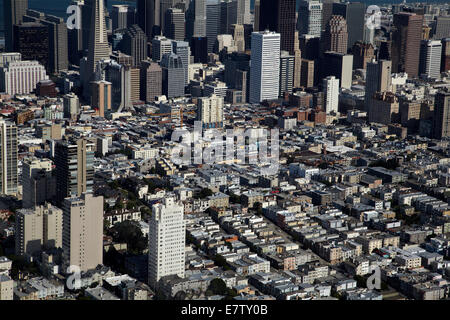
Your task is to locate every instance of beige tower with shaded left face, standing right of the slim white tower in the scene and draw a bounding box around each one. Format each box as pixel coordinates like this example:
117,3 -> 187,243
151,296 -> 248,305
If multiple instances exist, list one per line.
365,60 -> 392,111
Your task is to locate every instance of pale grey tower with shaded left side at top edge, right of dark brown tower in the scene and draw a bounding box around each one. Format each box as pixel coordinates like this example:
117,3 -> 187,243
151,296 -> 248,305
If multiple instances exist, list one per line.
297,0 -> 322,37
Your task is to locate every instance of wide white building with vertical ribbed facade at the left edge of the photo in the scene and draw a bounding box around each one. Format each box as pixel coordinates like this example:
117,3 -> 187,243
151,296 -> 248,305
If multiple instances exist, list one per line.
0,61 -> 48,95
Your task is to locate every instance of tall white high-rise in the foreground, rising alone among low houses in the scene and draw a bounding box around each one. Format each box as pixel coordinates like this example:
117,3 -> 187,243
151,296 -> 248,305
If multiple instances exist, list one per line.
148,198 -> 186,288
